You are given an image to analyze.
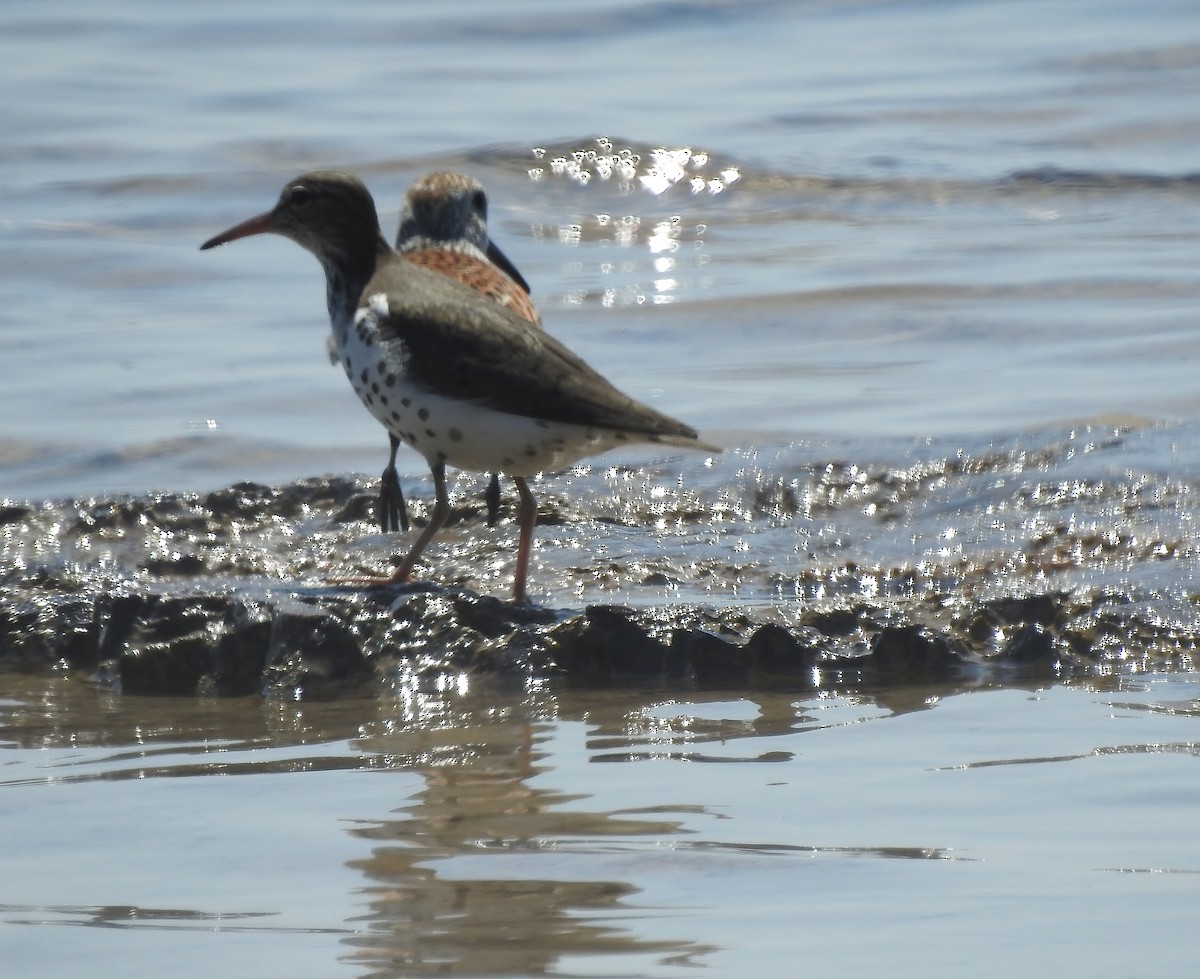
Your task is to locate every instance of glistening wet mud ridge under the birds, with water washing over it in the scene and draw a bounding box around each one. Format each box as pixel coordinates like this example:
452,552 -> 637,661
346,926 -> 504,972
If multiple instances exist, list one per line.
0,419 -> 1200,696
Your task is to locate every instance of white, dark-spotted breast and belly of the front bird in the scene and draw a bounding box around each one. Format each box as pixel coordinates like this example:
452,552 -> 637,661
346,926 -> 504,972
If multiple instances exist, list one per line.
324,325 -> 638,476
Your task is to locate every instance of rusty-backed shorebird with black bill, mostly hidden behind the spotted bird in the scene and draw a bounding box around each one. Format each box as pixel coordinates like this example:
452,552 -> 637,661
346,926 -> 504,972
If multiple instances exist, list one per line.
340,173 -> 541,531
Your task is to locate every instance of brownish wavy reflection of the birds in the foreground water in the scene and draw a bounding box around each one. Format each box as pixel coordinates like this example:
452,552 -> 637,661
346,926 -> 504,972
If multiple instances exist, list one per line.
347,698 -> 707,975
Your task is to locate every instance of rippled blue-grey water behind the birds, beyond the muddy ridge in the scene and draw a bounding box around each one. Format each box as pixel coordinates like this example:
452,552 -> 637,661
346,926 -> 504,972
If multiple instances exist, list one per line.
0,2 -> 1200,498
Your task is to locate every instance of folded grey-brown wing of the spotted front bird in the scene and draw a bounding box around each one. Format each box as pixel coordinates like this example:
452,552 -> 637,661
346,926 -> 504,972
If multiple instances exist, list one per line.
360,259 -> 713,449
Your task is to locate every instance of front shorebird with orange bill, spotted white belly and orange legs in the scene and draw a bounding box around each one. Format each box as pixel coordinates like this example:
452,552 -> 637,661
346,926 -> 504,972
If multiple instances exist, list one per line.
200,170 -> 719,602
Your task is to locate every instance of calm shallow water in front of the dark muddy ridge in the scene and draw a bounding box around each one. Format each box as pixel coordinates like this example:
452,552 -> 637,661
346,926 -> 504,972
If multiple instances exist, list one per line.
0,675 -> 1200,977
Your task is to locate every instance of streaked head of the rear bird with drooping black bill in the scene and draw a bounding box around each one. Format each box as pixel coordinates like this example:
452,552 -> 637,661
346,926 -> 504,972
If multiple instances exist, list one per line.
396,172 -> 529,293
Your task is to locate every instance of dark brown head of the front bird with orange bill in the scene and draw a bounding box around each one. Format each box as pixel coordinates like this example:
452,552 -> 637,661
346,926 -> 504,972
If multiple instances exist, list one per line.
200,170 -> 380,263
